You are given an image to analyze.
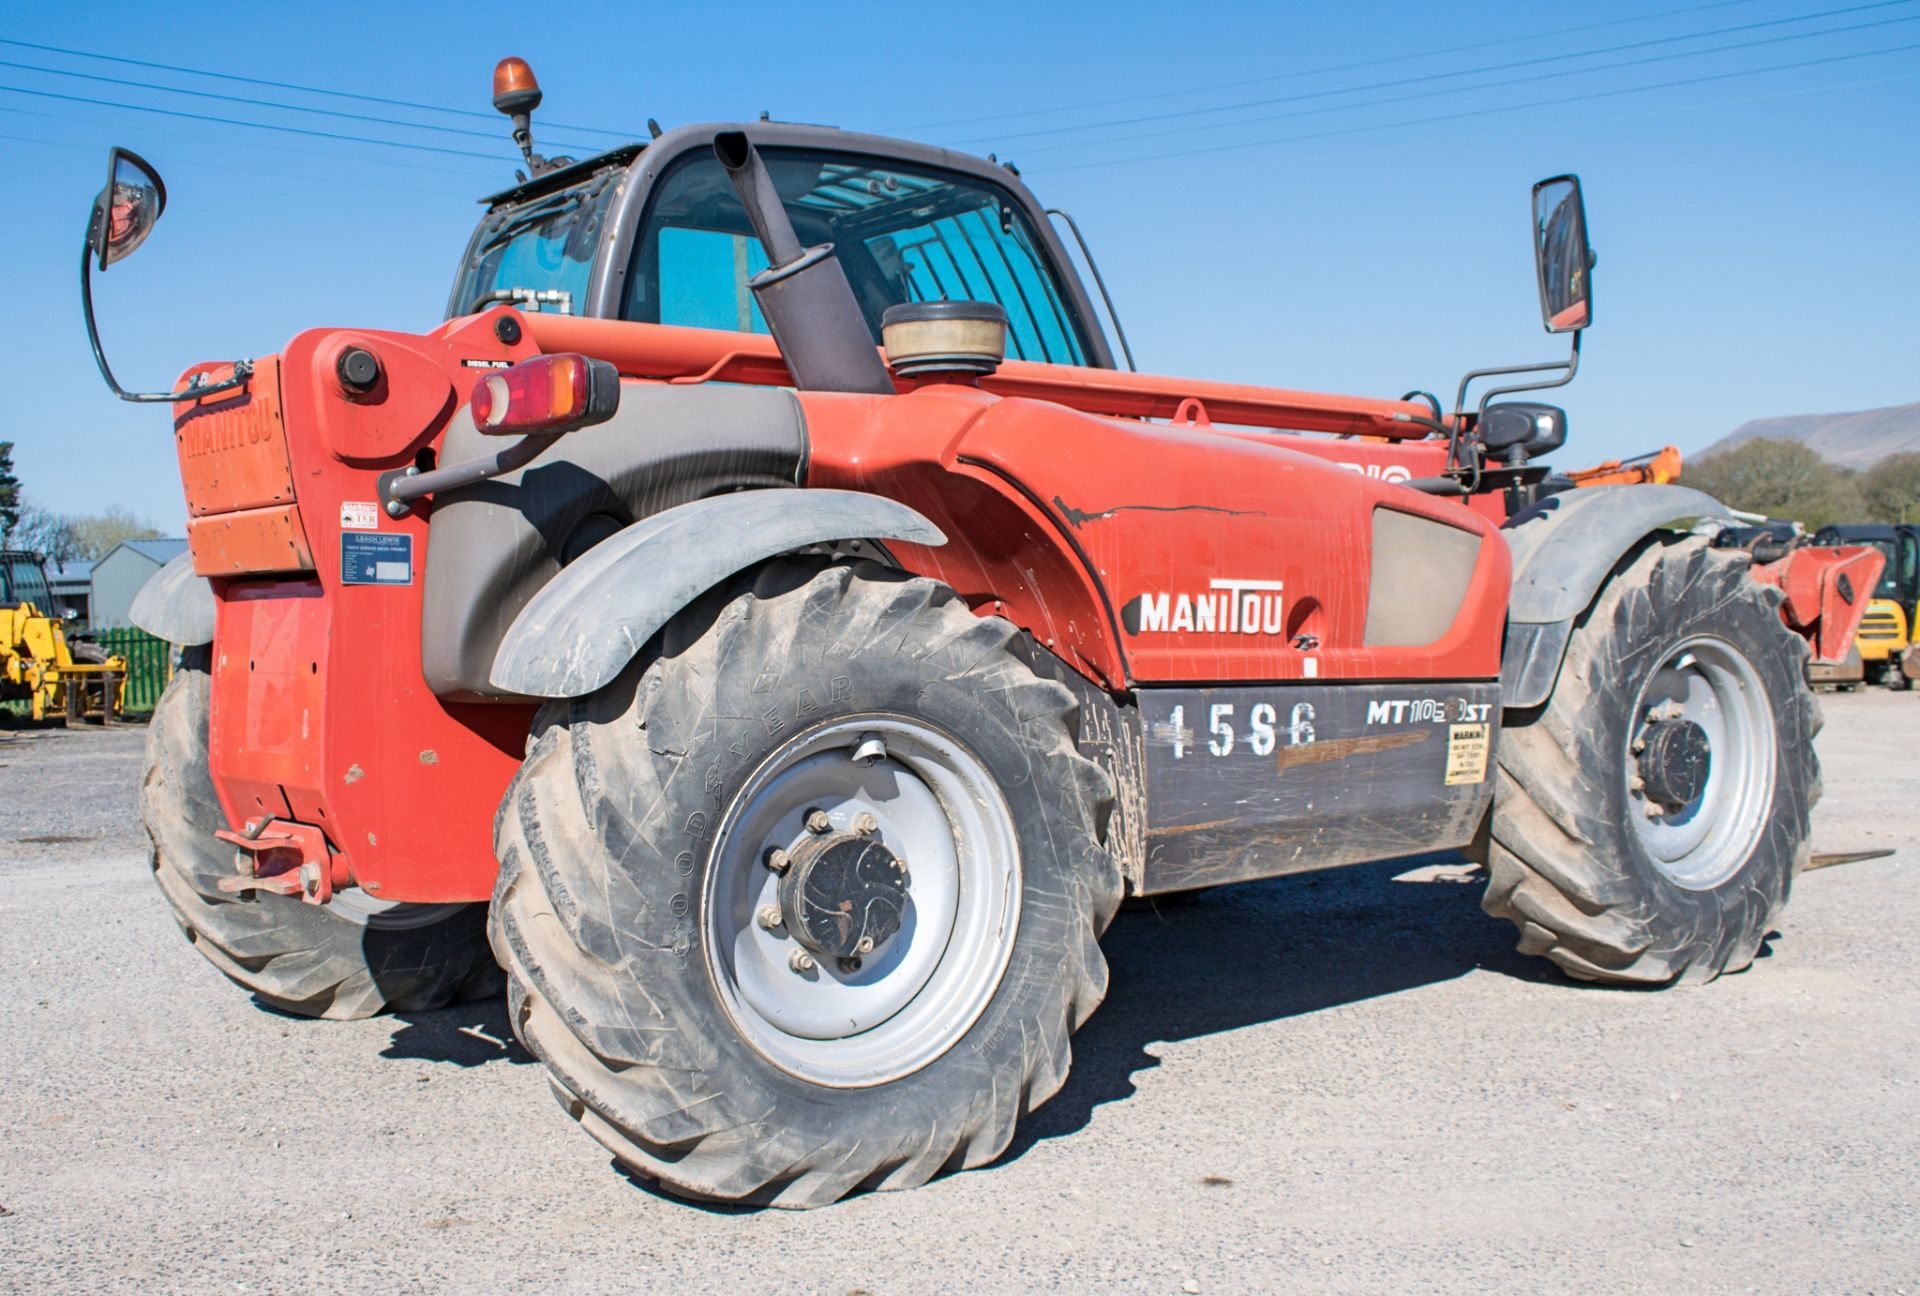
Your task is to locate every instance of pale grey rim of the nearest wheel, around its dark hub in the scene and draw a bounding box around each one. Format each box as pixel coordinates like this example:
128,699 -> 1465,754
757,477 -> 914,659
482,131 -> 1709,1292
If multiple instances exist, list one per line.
703,714 -> 1021,1089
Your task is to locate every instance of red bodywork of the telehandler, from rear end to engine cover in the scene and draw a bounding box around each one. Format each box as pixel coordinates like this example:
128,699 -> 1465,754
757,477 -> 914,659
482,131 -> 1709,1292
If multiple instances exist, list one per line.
175,311 -> 1509,902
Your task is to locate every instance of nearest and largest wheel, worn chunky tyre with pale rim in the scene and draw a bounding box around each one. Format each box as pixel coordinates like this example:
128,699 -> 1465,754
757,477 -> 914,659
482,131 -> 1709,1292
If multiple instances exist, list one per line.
492,563 -> 1121,1208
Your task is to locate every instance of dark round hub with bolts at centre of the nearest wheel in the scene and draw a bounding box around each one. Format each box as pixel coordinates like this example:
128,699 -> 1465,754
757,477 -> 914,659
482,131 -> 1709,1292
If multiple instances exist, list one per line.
780,833 -> 908,958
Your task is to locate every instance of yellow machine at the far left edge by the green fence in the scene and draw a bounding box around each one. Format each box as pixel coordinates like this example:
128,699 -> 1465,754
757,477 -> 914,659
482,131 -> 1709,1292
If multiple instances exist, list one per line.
0,551 -> 127,722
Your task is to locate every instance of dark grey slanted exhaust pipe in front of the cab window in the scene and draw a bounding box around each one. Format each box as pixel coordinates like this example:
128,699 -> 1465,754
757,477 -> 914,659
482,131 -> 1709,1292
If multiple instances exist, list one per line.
714,131 -> 893,396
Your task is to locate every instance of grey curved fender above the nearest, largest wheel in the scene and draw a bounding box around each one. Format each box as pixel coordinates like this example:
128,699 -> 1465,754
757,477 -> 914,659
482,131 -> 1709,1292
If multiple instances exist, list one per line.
492,490 -> 947,697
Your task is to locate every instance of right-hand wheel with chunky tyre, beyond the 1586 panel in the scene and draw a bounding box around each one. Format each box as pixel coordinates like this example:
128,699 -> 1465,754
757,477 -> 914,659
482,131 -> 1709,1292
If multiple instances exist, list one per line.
1482,538 -> 1820,985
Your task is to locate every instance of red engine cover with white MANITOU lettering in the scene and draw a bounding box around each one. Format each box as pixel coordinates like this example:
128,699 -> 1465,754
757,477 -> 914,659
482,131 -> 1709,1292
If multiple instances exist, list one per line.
825,388 -> 1509,685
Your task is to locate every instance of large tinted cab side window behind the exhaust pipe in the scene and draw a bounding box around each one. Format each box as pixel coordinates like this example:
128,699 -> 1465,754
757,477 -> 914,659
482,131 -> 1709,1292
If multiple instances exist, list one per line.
622,148 -> 1087,365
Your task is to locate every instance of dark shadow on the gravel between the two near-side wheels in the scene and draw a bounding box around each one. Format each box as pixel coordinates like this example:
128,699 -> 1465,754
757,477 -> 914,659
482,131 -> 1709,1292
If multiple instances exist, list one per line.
1000,852 -> 1561,1164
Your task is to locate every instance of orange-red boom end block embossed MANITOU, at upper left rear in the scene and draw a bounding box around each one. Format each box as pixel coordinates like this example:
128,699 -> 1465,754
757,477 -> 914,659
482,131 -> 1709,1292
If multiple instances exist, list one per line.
173,355 -> 313,576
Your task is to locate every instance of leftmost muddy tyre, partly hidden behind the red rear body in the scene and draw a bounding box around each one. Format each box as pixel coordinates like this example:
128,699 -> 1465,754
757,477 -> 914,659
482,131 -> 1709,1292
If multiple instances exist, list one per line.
140,647 -> 501,1018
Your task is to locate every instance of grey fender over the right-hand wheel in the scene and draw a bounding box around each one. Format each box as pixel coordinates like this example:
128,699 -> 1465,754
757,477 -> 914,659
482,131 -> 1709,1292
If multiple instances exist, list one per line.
1500,486 -> 1732,707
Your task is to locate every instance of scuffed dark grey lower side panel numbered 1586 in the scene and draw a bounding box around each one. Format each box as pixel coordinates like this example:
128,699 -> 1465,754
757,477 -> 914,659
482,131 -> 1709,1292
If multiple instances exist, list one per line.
1139,682 -> 1500,893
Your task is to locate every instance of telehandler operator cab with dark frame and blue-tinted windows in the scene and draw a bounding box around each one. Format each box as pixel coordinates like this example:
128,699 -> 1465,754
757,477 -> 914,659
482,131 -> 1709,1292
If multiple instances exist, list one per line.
447,60 -> 1114,369
